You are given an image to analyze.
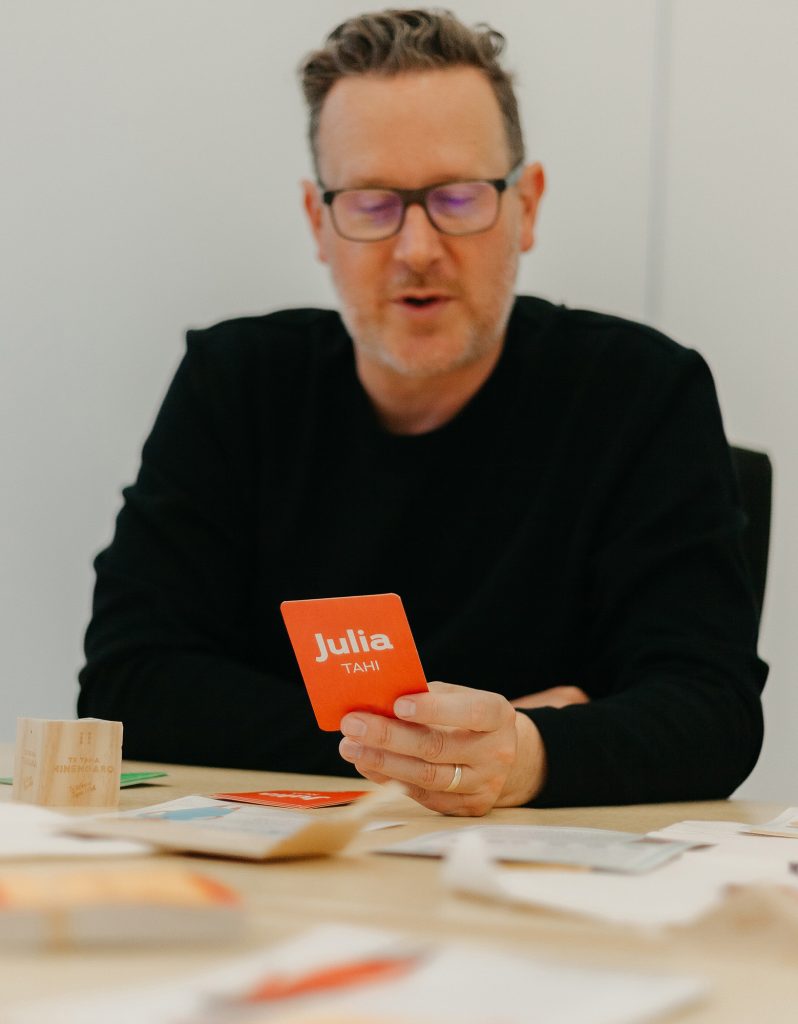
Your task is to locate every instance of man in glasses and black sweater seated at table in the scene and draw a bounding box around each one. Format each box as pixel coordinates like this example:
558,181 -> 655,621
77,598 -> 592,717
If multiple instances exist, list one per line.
79,10 -> 765,814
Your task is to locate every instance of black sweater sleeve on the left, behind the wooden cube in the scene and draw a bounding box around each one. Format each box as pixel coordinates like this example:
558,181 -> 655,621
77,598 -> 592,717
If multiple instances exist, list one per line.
78,331 -> 351,774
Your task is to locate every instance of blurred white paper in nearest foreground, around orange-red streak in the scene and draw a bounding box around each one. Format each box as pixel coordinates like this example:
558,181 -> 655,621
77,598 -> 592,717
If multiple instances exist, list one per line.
4,925 -> 705,1024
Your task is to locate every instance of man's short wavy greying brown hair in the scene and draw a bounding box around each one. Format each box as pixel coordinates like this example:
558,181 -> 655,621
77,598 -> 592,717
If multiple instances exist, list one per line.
299,8 -> 523,175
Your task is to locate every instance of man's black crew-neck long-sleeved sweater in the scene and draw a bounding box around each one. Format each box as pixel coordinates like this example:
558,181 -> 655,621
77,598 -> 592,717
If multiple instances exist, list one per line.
79,298 -> 766,806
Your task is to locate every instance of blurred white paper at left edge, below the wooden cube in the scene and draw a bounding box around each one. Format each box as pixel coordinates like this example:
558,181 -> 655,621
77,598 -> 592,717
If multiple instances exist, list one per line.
0,803 -> 155,860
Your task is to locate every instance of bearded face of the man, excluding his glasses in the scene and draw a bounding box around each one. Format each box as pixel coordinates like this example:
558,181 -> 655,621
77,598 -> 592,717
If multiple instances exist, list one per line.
304,68 -> 543,379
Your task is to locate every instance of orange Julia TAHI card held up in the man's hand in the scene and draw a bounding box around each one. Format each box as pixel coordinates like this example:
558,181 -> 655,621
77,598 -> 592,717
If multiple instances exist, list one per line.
280,594 -> 427,732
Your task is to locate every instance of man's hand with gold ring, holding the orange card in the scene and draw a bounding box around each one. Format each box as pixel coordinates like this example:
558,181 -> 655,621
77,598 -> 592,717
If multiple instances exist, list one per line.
340,682 -> 546,815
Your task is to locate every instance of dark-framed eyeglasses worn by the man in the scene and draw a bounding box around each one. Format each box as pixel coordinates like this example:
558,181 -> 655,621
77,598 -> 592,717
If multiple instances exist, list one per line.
322,163 -> 523,242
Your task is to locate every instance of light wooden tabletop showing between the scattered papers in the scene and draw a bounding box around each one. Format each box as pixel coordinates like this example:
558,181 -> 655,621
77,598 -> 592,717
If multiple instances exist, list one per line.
0,763 -> 798,1024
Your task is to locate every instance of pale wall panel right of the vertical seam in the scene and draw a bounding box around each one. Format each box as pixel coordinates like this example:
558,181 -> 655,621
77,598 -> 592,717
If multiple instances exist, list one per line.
650,0 -> 798,802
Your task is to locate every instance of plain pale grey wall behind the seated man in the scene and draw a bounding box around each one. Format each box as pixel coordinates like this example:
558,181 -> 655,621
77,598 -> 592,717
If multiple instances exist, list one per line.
0,0 -> 798,803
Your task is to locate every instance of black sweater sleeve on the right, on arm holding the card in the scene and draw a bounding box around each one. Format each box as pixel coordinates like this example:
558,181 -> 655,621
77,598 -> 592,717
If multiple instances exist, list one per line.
526,352 -> 767,807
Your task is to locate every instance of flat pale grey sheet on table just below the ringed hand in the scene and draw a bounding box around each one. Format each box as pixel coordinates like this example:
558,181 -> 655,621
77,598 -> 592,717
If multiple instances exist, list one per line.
377,825 -> 689,873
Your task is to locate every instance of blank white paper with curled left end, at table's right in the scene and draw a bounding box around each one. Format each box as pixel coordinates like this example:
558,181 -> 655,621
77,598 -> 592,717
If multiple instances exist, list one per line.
443,835 -> 798,929
